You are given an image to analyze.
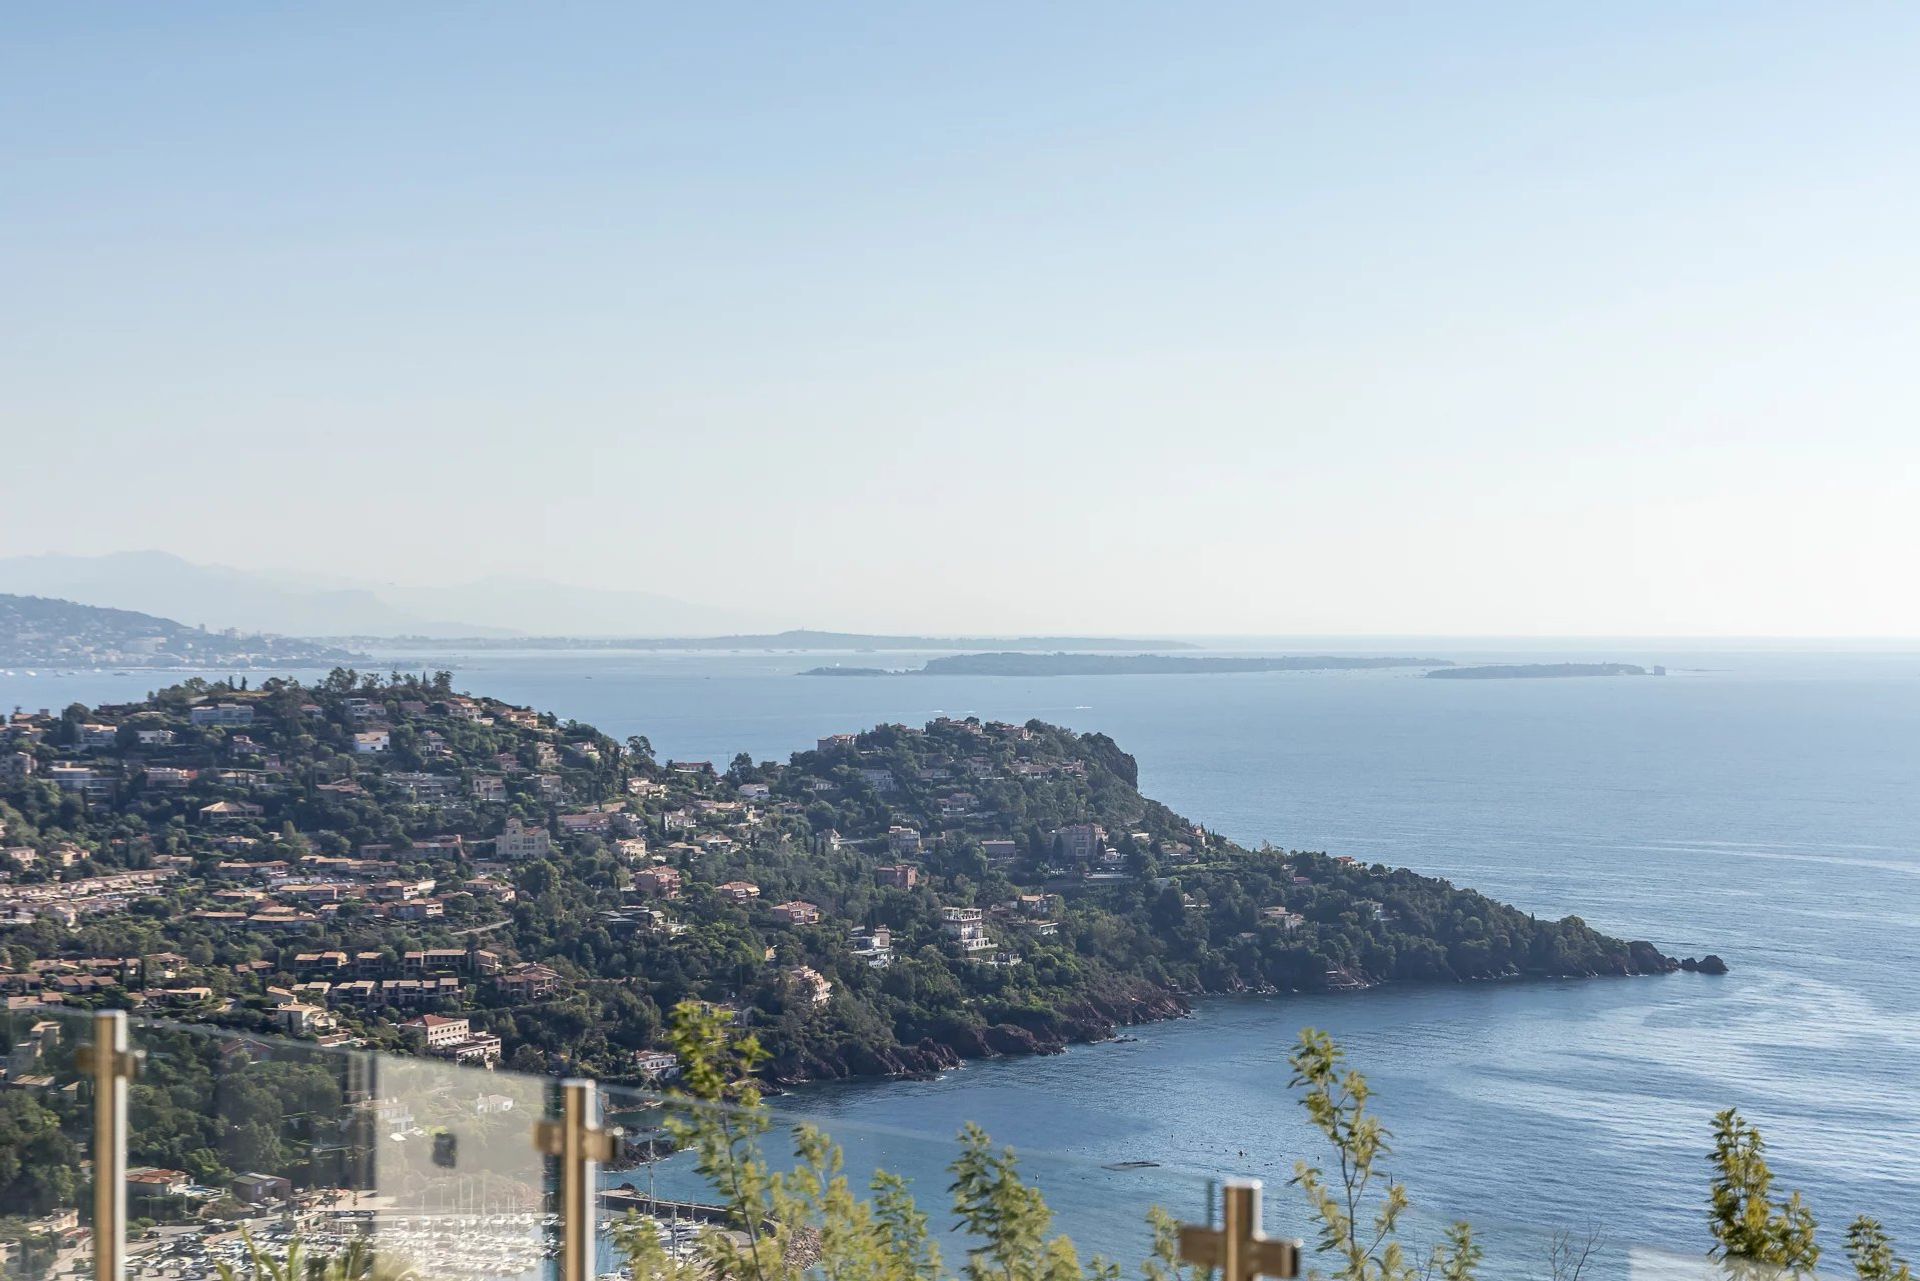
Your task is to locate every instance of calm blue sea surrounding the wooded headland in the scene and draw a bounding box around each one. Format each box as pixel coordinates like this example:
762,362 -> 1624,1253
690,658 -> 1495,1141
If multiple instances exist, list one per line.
0,643 -> 1920,1267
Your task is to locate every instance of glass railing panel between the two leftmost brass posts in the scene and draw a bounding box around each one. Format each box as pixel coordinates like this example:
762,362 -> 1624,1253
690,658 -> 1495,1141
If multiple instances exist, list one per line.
127,1020 -> 557,1279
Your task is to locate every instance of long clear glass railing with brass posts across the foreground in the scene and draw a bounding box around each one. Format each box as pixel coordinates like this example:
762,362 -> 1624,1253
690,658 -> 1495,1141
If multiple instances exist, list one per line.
0,1008 -> 1851,1281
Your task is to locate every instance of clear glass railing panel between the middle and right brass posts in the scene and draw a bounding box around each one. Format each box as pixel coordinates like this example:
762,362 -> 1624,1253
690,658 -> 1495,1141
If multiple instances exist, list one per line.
595,1087 -> 1215,1277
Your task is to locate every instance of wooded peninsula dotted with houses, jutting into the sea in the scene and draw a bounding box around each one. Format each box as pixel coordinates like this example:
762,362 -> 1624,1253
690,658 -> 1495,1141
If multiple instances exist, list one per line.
0,670 -> 1678,1081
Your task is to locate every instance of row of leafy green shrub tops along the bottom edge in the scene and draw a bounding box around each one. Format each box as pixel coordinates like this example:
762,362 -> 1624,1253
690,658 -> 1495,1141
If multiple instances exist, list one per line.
187,1003 -> 1914,1281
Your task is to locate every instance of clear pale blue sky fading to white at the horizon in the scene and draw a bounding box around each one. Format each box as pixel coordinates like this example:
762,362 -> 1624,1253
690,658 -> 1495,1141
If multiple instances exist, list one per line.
0,2 -> 1920,636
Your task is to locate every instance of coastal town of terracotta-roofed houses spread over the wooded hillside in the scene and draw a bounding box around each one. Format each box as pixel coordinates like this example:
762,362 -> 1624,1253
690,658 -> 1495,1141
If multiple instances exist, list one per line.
0,691 -> 1213,1079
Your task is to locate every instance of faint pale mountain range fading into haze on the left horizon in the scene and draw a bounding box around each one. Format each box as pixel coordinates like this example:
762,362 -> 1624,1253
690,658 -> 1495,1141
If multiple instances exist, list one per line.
0,551 -> 770,638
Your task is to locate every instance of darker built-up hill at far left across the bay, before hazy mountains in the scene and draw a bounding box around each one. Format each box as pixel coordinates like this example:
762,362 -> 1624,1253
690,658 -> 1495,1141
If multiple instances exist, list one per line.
0,595 -> 357,668
